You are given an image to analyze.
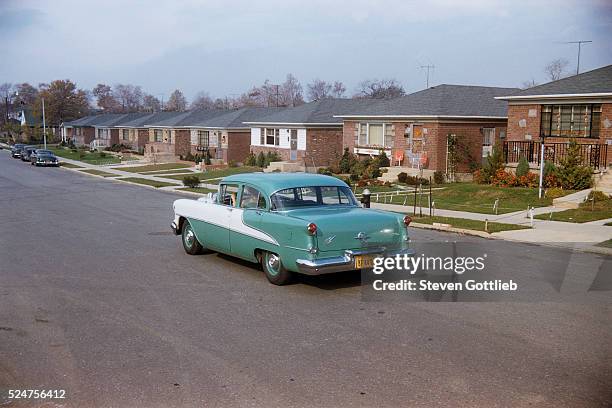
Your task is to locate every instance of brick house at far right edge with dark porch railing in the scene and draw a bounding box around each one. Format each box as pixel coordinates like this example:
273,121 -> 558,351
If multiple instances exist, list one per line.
497,65 -> 612,169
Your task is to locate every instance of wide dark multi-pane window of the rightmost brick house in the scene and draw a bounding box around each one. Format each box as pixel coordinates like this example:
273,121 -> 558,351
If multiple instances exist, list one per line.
540,104 -> 601,138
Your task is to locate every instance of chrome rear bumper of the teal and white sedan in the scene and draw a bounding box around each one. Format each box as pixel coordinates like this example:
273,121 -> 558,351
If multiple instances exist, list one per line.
295,248 -> 414,275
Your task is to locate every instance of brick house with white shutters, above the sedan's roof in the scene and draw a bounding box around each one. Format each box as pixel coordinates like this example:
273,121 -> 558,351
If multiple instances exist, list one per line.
245,98 -> 367,167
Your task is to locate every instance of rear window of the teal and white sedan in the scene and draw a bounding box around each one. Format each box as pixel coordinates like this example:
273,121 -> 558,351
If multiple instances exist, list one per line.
270,186 -> 357,211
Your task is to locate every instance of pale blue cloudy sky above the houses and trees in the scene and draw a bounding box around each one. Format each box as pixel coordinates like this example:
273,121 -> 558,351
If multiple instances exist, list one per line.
0,0 -> 612,98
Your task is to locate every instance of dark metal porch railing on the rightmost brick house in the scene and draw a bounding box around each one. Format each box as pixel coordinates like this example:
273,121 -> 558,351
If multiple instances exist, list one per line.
504,141 -> 608,169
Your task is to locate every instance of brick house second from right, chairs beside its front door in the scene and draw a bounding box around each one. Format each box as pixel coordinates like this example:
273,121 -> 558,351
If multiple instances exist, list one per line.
336,85 -> 518,174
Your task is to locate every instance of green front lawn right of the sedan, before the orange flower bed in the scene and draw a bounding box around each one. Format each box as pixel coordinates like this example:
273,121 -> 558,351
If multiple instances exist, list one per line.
380,183 -> 572,214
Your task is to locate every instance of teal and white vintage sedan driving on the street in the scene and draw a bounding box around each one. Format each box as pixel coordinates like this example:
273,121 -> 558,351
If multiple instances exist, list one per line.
172,173 -> 412,285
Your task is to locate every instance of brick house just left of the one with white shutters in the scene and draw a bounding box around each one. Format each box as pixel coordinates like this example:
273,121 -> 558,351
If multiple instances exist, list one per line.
176,107 -> 282,163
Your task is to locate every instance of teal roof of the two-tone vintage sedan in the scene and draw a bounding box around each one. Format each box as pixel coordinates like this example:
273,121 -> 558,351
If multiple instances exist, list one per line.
221,173 -> 346,195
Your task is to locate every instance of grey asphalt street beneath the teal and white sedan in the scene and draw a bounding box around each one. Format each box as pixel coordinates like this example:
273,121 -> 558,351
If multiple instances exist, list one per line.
0,151 -> 612,407
